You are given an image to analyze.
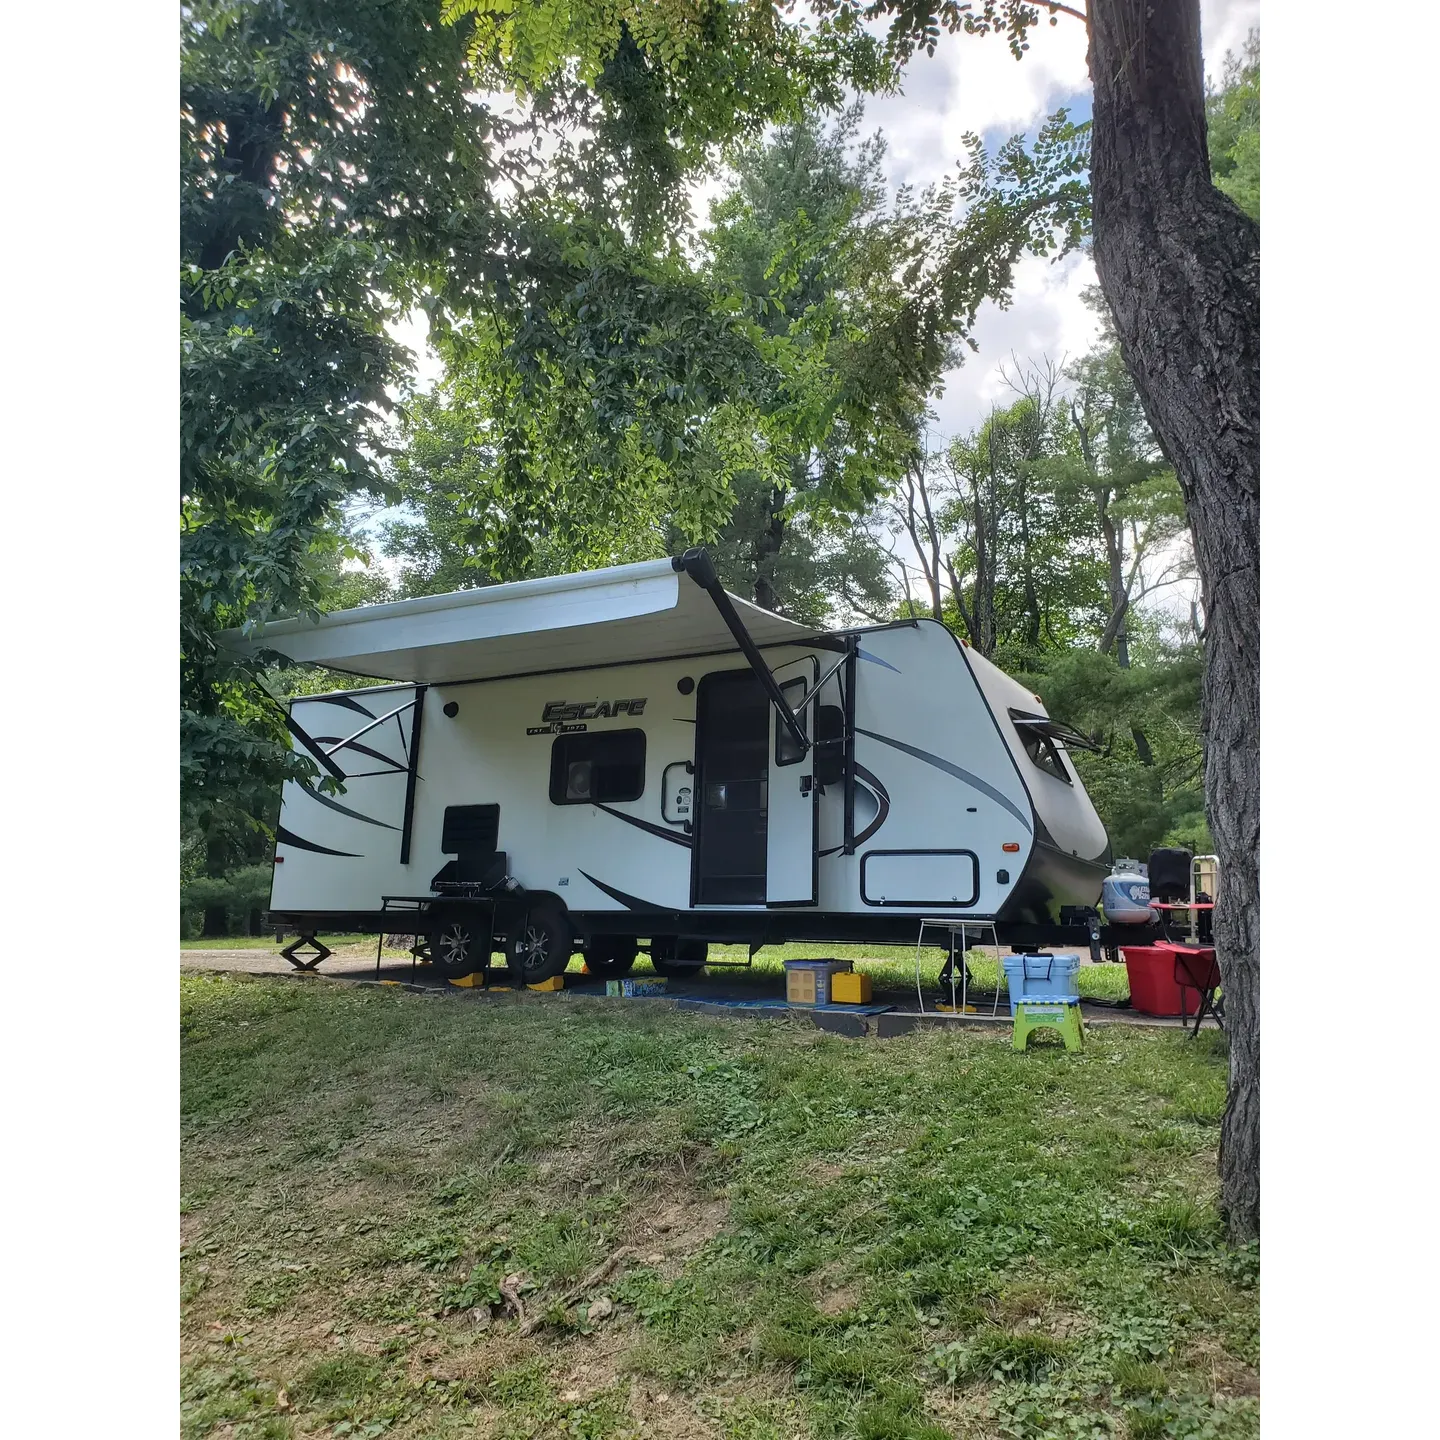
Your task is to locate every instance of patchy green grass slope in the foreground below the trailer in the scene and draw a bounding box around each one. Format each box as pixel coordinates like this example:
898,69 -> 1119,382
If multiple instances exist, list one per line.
180,975 -> 1259,1440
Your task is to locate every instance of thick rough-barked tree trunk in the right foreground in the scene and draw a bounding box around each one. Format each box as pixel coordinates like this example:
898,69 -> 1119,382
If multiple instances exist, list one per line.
1090,0 -> 1260,1240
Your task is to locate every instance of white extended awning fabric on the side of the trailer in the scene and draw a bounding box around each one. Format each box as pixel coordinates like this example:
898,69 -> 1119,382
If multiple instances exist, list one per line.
225,560 -> 824,684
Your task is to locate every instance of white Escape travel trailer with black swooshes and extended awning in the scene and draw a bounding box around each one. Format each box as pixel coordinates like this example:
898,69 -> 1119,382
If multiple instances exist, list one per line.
232,550 -> 1110,984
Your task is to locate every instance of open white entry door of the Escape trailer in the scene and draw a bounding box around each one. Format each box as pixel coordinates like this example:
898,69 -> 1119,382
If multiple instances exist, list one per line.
765,655 -> 819,906
